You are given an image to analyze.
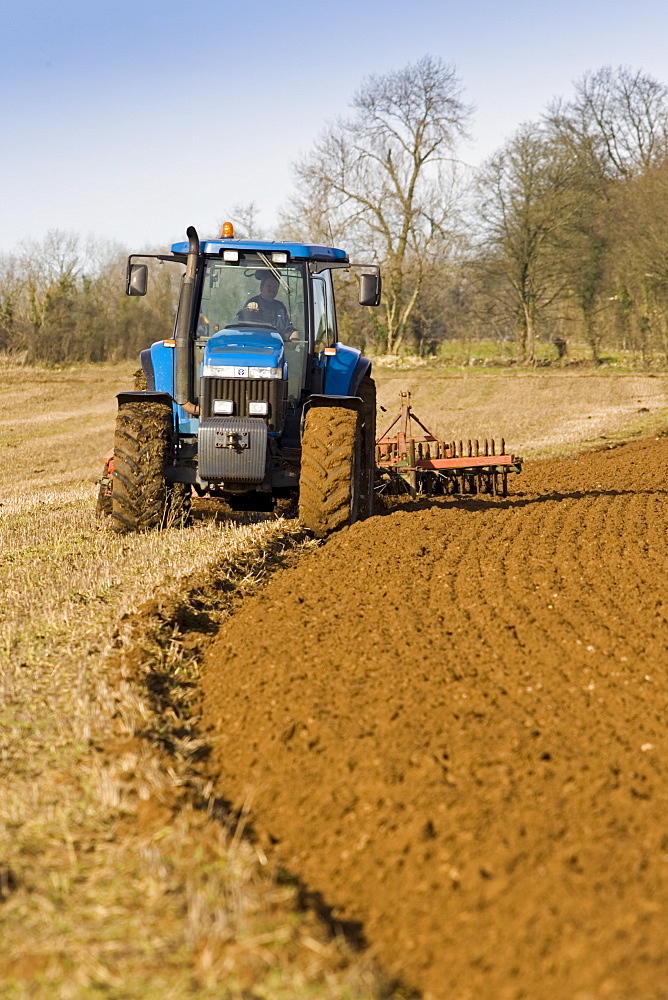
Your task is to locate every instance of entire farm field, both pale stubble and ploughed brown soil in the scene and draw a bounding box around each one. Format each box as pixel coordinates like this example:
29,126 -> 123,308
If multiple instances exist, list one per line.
0,366 -> 668,1000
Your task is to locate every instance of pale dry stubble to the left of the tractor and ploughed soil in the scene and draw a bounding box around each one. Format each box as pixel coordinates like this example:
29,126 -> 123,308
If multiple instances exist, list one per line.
0,366 -> 408,1000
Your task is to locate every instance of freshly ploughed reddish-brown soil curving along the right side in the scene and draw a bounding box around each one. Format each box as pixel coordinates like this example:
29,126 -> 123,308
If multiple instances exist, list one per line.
204,438 -> 668,1000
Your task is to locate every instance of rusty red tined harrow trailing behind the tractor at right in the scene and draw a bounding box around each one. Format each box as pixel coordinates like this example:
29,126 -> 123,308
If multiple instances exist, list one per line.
376,392 -> 522,496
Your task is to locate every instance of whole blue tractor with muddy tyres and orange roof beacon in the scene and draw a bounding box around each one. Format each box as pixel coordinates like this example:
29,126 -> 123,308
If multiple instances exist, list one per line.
110,223 -> 381,537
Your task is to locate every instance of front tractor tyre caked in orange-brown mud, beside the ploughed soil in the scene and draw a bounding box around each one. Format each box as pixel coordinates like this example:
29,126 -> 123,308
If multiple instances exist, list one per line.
299,406 -> 362,538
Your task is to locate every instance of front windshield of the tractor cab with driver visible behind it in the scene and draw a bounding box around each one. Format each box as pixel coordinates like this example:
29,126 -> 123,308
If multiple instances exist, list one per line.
197,254 -> 305,341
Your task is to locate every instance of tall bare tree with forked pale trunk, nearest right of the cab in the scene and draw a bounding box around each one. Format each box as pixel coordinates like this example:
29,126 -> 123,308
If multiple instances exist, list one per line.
282,56 -> 470,353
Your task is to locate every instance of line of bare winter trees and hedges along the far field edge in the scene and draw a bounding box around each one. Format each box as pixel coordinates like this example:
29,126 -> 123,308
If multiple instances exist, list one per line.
0,56 -> 668,364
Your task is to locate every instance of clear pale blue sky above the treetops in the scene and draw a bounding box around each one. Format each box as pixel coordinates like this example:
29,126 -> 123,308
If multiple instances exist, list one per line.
0,0 -> 668,251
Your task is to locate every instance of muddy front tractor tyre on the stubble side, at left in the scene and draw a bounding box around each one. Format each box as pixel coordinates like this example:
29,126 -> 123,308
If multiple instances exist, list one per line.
111,402 -> 173,532
